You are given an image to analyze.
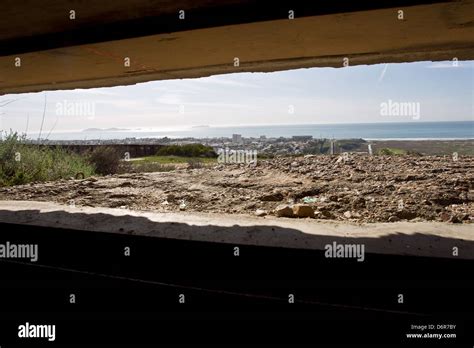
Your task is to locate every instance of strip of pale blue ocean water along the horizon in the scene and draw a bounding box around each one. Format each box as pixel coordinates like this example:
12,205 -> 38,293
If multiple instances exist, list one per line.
29,121 -> 474,140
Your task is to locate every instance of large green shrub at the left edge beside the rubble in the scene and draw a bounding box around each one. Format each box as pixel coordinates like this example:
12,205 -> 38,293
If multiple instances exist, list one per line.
0,132 -> 94,186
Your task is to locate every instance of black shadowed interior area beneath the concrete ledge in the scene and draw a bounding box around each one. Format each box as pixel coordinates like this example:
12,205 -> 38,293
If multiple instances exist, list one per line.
0,224 -> 474,348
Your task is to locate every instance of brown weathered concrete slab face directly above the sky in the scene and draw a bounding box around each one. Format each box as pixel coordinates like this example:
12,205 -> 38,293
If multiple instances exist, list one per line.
0,0 -> 474,94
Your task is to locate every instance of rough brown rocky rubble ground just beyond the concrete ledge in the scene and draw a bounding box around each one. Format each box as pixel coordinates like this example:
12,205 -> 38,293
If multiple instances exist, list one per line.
0,154 -> 474,223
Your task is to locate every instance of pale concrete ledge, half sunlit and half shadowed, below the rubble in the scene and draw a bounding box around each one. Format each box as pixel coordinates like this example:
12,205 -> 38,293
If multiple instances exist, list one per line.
0,201 -> 474,259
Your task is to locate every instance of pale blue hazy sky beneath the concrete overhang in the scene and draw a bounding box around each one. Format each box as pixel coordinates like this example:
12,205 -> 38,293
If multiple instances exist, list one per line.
0,61 -> 474,133
